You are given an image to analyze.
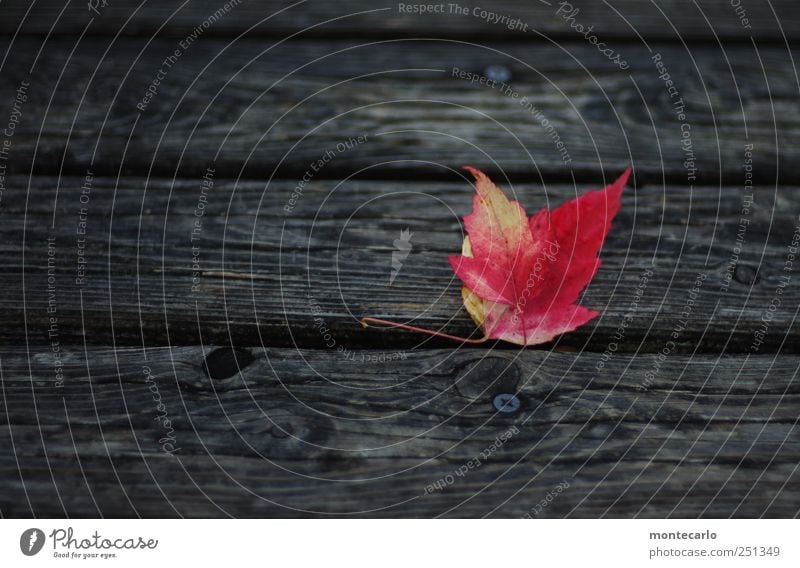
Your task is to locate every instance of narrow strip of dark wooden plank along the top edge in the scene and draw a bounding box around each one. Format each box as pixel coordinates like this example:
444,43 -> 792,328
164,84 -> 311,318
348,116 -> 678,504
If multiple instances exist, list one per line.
0,0 -> 800,41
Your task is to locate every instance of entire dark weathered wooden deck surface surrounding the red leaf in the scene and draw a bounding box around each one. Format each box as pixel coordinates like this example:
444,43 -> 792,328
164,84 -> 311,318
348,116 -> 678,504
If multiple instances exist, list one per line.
0,0 -> 800,518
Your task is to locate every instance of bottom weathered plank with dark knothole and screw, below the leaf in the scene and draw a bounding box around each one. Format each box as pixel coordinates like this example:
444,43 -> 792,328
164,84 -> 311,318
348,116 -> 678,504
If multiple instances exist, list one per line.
0,346 -> 800,517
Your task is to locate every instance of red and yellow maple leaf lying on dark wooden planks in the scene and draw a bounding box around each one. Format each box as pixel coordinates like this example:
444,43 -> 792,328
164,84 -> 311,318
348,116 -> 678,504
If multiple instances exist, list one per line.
449,167 -> 630,345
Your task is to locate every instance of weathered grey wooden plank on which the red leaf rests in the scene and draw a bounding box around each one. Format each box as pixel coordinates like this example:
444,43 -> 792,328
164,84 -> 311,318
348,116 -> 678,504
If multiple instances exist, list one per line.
0,173 -> 800,353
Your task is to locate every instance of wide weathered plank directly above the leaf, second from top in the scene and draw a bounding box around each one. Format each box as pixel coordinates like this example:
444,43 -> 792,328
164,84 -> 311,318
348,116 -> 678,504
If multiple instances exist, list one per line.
0,38 -> 800,185
